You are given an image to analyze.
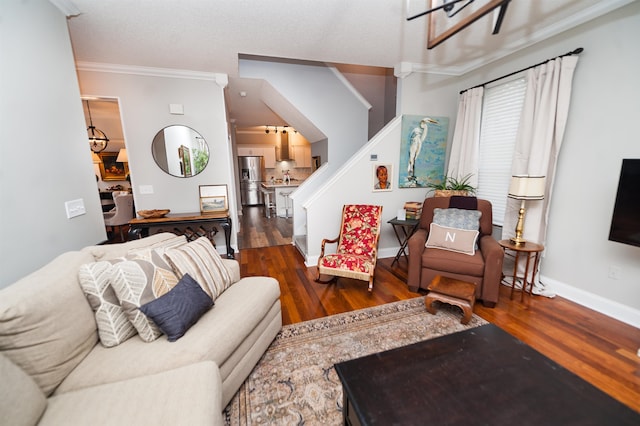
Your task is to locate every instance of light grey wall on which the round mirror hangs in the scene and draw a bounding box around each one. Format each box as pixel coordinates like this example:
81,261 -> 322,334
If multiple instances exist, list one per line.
78,68 -> 237,251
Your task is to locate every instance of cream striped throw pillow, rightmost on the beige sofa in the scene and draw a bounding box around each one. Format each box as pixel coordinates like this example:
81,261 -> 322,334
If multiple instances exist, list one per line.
164,237 -> 231,301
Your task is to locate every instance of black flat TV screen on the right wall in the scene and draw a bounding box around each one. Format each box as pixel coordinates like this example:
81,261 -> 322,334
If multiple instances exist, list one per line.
609,158 -> 640,247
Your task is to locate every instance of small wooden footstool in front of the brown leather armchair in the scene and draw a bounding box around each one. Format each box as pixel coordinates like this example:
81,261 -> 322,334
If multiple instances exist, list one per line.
424,275 -> 476,324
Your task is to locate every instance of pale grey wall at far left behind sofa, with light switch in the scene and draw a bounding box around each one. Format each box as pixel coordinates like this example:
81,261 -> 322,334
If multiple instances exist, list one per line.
0,0 -> 106,287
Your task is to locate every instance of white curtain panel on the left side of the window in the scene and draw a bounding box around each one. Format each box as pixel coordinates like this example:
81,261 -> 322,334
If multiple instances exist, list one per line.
447,87 -> 484,187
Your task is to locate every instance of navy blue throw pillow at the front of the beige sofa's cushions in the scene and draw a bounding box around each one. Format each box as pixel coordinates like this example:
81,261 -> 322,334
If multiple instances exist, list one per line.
140,274 -> 213,342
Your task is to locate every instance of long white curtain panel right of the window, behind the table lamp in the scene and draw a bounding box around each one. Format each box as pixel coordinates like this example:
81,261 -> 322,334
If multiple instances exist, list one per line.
502,55 -> 578,296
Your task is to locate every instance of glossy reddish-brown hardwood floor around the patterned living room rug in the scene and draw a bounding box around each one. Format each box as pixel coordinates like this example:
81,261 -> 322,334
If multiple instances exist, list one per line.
237,243 -> 640,412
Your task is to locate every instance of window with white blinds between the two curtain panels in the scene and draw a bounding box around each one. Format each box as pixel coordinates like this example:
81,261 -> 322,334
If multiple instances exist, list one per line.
477,77 -> 526,226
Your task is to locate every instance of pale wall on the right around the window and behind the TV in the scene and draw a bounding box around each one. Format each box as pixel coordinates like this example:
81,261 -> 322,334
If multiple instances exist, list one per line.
402,2 -> 640,326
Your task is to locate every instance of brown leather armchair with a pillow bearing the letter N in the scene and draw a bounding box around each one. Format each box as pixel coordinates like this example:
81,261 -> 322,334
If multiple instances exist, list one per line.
407,197 -> 504,308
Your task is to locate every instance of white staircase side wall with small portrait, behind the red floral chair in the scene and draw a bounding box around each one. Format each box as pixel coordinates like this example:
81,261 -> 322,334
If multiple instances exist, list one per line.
304,70 -> 458,265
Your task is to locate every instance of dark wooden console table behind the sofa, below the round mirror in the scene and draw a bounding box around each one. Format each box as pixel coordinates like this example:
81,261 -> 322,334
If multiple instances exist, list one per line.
129,213 -> 234,259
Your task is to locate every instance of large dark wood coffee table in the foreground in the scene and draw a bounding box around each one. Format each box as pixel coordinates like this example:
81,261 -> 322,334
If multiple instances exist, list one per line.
335,324 -> 640,426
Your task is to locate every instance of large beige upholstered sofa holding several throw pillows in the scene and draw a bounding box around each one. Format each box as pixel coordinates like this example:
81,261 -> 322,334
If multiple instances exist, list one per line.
0,234 -> 282,425
